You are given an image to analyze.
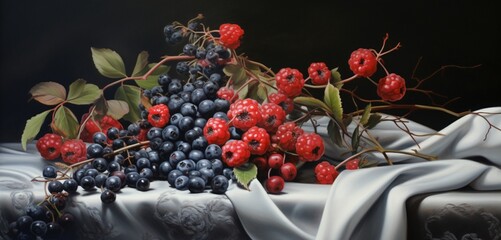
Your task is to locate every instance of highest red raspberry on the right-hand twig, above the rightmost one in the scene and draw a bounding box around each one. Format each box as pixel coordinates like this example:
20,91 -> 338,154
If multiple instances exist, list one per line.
348,48 -> 377,77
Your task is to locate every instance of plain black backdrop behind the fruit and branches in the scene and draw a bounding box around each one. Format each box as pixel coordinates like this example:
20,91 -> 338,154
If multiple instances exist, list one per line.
0,0 -> 501,142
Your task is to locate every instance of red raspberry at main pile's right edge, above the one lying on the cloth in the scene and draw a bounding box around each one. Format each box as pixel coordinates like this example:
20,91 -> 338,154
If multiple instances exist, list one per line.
296,133 -> 325,162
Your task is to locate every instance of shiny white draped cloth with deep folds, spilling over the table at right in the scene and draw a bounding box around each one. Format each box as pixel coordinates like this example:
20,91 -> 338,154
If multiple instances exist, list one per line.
226,107 -> 501,240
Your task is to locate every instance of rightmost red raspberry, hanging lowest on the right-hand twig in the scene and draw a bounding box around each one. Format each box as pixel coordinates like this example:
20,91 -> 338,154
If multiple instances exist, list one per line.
377,73 -> 406,102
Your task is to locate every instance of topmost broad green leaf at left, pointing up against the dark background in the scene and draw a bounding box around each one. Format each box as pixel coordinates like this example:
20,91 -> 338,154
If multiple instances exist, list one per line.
90,48 -> 126,78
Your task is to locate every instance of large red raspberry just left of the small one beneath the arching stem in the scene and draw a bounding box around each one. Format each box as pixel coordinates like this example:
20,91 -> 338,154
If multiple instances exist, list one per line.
275,68 -> 304,98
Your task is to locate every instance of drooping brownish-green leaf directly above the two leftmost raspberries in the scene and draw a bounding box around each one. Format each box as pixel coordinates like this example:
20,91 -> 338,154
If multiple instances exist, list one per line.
51,106 -> 80,138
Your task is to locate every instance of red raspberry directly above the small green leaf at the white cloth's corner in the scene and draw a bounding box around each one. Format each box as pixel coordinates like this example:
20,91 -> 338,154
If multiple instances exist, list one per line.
221,140 -> 250,167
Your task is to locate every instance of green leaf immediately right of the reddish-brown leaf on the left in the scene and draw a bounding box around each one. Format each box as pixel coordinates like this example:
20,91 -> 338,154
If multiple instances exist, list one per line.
68,79 -> 102,105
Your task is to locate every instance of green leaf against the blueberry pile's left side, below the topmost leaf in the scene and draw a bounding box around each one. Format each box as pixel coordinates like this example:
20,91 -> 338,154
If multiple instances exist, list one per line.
115,84 -> 141,122
